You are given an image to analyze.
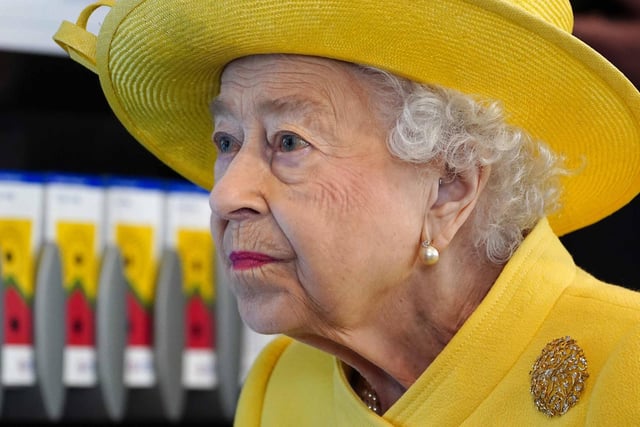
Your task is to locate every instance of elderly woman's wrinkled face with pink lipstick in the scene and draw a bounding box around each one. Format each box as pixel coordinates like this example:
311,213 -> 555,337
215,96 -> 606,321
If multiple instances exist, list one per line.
210,56 -> 428,336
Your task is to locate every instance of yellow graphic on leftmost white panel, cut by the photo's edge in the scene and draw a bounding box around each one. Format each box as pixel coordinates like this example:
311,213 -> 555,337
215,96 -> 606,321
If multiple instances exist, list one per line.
0,219 -> 35,300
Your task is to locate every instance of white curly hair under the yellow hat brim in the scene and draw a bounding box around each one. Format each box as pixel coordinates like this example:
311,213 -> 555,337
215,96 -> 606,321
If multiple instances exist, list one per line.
357,66 -> 566,264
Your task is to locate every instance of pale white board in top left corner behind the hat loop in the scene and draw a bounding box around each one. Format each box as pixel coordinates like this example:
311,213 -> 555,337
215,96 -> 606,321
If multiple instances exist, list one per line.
0,0 -> 109,56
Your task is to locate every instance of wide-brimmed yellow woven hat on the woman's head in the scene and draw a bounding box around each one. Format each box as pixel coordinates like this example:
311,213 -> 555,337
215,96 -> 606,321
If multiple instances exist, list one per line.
54,0 -> 640,235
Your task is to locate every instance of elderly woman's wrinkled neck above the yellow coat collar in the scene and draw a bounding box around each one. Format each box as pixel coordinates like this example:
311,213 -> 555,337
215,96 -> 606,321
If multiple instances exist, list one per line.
294,252 -> 502,412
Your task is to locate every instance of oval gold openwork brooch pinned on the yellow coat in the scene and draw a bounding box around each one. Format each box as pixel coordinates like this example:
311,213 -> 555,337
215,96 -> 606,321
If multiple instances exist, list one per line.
529,336 -> 589,417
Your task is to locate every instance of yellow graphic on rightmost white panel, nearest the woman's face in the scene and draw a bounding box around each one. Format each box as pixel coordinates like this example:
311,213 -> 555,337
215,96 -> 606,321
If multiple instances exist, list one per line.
176,229 -> 215,303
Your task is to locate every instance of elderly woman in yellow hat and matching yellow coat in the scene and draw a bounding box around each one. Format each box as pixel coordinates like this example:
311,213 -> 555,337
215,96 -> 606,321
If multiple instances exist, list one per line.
56,0 -> 640,426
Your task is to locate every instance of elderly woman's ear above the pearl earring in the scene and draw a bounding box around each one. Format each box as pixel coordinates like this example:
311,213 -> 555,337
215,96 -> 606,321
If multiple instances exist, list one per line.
425,166 -> 491,251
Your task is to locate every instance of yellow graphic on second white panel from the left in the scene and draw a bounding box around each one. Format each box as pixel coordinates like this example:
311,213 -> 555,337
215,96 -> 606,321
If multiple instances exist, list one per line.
56,221 -> 99,301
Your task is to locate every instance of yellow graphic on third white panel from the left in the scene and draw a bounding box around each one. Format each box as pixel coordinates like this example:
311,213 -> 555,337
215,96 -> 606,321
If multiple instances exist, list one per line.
115,224 -> 156,306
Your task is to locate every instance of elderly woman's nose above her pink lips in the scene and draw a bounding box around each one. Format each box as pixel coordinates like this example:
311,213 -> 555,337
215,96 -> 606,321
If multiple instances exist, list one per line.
209,146 -> 269,220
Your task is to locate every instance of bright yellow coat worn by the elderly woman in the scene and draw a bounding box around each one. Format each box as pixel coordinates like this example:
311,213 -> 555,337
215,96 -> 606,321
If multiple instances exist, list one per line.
235,220 -> 640,427
